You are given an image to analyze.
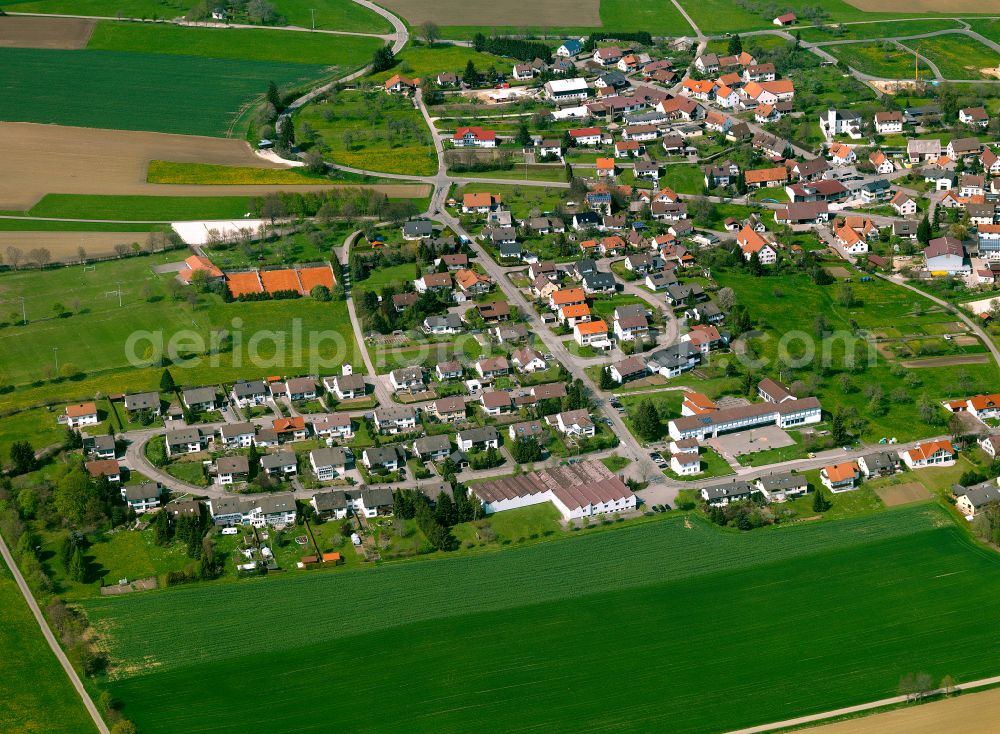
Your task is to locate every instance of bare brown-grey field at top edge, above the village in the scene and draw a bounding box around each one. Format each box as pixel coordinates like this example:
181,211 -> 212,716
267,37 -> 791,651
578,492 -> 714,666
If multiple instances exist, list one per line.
380,0 -> 601,27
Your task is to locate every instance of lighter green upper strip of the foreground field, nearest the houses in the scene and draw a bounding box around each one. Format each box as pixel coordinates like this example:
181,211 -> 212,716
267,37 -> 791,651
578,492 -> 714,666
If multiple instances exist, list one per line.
87,508 -> 937,680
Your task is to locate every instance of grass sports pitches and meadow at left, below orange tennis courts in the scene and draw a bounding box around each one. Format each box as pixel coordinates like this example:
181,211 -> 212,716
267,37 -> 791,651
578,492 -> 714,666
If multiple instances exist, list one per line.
0,250 -> 360,408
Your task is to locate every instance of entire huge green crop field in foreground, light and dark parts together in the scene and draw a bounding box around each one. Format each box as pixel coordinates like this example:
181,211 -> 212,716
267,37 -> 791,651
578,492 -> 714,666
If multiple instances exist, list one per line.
84,505 -> 1000,734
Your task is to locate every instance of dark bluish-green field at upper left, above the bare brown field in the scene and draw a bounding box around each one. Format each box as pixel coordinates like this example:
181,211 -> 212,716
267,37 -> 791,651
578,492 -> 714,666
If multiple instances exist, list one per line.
0,47 -> 326,137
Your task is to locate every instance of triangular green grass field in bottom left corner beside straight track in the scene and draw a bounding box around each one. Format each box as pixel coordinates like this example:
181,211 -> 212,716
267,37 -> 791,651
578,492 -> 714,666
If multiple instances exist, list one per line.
0,562 -> 95,734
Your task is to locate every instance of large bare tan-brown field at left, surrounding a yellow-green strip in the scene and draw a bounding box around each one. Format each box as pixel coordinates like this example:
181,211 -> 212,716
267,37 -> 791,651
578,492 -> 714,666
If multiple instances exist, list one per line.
0,122 -> 429,211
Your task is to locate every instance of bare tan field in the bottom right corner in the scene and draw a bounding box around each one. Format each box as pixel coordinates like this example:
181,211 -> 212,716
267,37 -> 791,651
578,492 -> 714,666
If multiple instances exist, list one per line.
805,689 -> 1000,734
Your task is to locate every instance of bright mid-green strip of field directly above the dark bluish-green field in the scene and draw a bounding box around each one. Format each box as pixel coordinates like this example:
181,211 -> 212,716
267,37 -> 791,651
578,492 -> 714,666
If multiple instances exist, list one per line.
87,20 -> 382,67
